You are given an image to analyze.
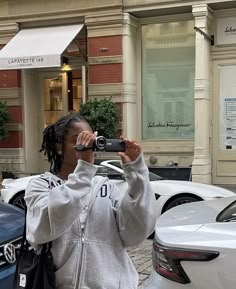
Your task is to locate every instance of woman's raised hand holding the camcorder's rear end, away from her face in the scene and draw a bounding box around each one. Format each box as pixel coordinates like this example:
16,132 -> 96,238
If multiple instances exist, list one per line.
118,136 -> 142,164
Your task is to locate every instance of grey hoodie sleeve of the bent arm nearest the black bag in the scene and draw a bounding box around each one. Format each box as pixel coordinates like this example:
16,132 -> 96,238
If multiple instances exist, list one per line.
25,160 -> 97,245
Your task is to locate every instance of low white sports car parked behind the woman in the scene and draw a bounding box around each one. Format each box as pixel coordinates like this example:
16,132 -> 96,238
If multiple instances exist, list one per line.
1,160 -> 235,215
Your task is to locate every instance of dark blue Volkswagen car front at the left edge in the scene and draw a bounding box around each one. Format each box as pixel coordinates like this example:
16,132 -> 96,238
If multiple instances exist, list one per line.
0,202 -> 25,289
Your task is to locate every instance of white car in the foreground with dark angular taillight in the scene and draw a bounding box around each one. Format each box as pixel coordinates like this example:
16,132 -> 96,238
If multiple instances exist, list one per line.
144,195 -> 236,289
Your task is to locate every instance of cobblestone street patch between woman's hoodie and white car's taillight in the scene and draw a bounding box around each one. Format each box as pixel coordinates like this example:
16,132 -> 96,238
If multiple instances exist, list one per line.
128,239 -> 152,289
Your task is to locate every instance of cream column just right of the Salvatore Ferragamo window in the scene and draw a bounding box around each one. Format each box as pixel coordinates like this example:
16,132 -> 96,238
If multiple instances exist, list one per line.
192,4 -> 212,184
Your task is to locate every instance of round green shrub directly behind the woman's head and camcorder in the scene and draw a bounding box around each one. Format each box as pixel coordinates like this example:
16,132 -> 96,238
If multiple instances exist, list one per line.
80,98 -> 120,138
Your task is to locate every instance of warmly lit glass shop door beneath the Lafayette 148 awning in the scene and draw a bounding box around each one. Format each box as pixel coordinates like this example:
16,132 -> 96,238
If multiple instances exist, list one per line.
38,70 -> 83,171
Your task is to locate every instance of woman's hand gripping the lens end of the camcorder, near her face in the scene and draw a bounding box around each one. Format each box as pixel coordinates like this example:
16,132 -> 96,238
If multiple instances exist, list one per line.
76,131 -> 97,164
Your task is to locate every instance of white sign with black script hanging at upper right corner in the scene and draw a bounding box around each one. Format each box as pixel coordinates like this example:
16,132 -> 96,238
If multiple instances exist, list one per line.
216,17 -> 236,45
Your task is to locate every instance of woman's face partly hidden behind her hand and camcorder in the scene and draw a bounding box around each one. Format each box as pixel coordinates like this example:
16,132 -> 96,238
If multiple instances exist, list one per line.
62,121 -> 93,172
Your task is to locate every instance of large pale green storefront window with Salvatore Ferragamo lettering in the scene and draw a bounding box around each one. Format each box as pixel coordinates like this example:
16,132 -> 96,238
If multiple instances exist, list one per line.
142,21 -> 195,140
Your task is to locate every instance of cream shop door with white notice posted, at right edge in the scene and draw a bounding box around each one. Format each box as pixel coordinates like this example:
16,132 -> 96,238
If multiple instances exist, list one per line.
212,59 -> 236,185
